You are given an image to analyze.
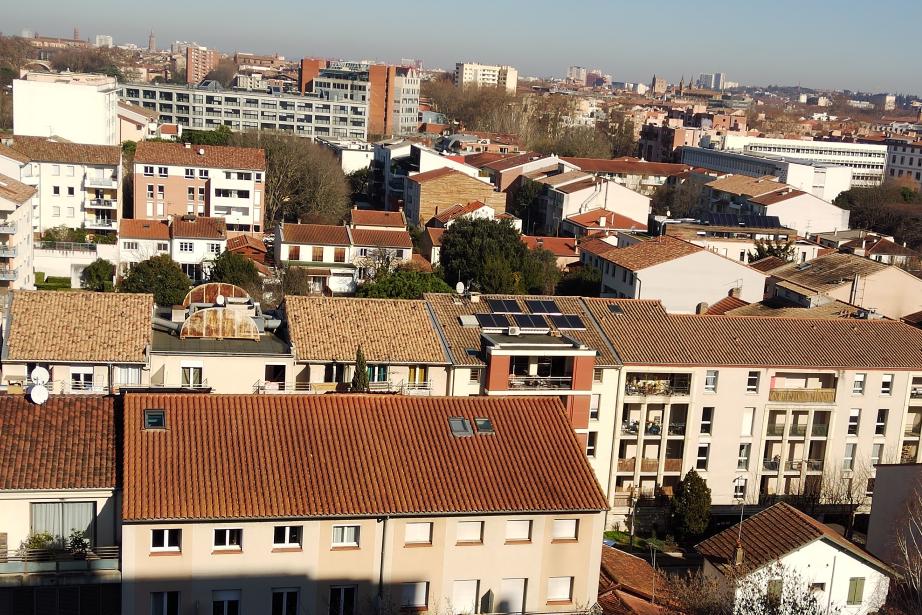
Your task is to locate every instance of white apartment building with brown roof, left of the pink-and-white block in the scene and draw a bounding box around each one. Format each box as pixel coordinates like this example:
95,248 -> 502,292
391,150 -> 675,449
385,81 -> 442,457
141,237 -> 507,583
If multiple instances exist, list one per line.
0,136 -> 122,233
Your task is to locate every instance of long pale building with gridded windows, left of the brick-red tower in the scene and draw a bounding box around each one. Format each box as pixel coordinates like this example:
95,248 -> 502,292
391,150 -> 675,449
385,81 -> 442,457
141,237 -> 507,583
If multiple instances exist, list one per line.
119,77 -> 368,139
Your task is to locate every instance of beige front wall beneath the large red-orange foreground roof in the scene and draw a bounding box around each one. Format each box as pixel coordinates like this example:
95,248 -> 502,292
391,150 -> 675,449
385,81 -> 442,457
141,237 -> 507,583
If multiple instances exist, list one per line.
122,513 -> 602,615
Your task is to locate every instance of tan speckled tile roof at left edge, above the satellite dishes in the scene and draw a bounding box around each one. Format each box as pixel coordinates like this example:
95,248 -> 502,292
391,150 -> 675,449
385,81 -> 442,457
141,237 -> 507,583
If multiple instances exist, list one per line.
5,290 -> 154,363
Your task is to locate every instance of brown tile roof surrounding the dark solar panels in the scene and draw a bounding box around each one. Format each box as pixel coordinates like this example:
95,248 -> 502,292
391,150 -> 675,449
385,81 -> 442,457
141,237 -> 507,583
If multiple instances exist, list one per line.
423,293 -> 620,367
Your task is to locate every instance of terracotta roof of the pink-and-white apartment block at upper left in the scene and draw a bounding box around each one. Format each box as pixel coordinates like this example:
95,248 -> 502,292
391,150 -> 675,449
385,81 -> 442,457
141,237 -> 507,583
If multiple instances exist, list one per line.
134,141 -> 266,171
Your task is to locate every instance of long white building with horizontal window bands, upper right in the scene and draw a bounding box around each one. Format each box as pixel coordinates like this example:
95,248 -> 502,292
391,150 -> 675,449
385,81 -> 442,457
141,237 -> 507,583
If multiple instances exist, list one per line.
702,133 -> 887,192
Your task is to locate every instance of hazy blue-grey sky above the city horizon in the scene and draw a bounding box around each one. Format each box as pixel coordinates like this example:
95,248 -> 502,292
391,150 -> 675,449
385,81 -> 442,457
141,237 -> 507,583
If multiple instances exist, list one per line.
0,0 -> 922,94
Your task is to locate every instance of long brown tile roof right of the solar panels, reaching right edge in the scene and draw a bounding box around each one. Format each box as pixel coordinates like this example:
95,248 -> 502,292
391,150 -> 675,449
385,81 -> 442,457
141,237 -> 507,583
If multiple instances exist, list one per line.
583,298 -> 922,369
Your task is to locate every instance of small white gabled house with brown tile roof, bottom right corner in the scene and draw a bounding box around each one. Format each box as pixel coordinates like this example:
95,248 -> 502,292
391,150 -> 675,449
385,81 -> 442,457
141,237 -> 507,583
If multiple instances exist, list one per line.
695,502 -> 893,615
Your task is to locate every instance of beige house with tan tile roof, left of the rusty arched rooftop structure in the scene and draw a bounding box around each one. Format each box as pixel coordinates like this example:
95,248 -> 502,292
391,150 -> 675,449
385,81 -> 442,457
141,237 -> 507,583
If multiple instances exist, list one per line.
0,290 -> 154,393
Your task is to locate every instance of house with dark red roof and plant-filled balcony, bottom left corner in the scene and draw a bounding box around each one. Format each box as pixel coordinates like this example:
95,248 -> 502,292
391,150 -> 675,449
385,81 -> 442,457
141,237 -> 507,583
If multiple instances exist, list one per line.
0,393 -> 121,613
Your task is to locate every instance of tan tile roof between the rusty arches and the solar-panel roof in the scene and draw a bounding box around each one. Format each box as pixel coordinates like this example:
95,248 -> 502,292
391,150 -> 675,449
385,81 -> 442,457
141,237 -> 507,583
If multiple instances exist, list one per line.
284,296 -> 448,364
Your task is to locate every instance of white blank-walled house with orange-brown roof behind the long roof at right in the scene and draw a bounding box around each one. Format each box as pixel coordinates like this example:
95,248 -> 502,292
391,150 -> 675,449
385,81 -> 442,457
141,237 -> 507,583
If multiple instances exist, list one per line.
580,235 -> 768,313
